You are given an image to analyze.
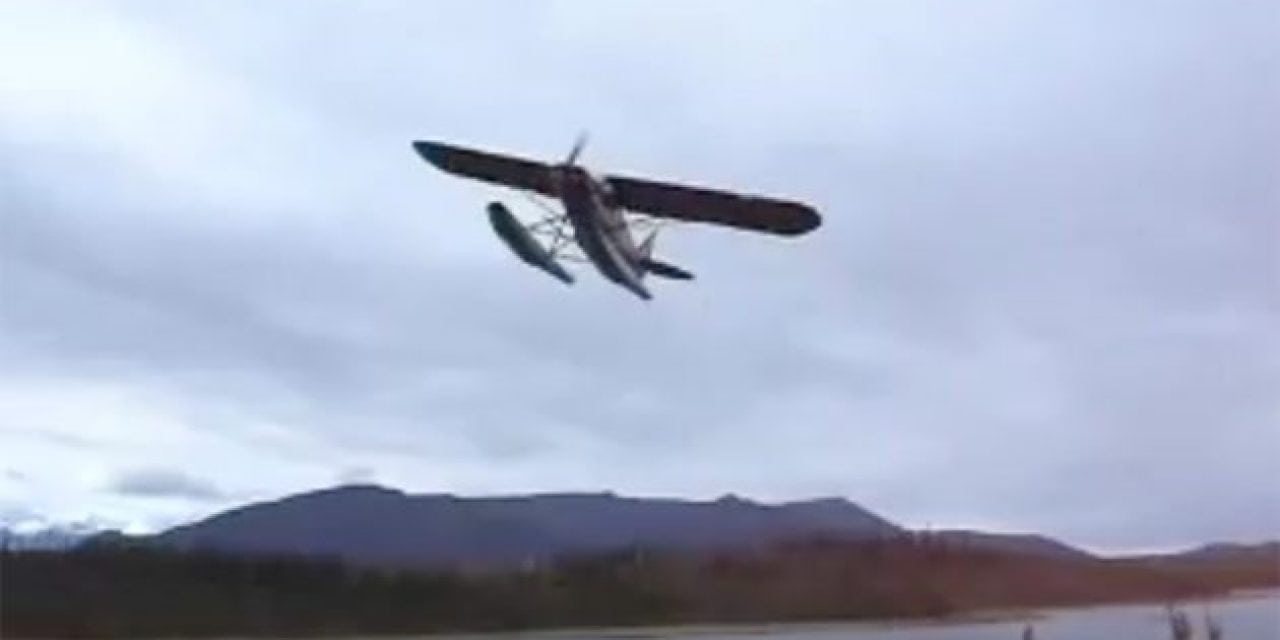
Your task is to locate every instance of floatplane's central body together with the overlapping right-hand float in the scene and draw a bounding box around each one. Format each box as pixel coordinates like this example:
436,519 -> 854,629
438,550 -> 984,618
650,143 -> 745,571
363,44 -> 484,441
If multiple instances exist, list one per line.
557,166 -> 653,300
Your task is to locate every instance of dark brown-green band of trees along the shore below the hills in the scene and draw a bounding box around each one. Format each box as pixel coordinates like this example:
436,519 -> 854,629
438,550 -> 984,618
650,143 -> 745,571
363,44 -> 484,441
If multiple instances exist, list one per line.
0,540 -> 1280,639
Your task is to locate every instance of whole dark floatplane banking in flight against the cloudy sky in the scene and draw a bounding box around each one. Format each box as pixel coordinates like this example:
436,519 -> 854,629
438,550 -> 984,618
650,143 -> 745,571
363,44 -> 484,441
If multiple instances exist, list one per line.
413,134 -> 822,301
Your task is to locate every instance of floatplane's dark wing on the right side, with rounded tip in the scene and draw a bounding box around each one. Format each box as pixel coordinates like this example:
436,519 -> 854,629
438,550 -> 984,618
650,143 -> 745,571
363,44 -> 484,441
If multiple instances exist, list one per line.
605,175 -> 822,236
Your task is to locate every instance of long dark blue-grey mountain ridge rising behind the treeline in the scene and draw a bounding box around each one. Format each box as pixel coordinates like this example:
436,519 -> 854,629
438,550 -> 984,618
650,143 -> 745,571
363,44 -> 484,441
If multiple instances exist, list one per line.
150,485 -> 904,566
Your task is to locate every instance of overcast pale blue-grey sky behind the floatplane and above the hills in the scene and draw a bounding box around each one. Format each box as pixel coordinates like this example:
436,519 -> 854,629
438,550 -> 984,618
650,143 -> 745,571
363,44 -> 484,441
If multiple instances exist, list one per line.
0,0 -> 1280,550
